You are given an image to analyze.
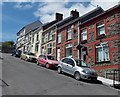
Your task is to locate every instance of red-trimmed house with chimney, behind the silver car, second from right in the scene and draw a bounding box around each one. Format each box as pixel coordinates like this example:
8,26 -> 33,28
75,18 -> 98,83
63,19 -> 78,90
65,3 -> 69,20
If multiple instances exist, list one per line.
56,10 -> 79,60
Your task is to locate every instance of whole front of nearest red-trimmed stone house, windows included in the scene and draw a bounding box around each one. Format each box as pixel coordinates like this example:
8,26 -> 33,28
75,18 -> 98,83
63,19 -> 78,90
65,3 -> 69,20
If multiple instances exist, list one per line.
79,5 -> 120,76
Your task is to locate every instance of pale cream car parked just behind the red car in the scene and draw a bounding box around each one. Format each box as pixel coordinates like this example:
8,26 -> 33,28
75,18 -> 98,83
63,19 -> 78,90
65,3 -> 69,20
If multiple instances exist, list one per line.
20,52 -> 36,62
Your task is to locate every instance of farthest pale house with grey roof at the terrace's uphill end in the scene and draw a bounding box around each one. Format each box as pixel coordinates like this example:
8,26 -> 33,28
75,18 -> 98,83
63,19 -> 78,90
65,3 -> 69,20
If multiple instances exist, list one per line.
16,20 -> 43,51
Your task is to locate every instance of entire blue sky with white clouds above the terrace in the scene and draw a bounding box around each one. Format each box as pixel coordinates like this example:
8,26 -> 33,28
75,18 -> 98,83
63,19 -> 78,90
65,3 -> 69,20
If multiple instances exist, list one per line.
0,0 -> 119,42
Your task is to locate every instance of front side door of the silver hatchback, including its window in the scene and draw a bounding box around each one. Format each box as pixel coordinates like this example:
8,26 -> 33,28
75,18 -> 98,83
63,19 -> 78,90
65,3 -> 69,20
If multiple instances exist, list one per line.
67,59 -> 75,75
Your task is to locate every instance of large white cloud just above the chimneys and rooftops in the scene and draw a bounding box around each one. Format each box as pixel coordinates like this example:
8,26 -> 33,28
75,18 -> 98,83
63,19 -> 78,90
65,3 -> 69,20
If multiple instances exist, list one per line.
34,0 -> 118,23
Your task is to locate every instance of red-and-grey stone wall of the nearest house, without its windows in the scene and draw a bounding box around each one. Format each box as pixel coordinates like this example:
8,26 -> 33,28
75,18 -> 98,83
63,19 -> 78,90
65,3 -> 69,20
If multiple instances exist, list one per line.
80,9 -> 120,74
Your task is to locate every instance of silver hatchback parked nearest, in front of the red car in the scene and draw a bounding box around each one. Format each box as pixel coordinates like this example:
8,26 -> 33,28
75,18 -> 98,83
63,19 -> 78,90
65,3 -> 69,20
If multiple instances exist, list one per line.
57,57 -> 97,80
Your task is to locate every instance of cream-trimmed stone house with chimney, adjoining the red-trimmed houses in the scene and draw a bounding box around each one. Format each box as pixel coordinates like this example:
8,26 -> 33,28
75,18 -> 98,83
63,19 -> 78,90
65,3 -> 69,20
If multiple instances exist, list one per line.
41,13 -> 63,57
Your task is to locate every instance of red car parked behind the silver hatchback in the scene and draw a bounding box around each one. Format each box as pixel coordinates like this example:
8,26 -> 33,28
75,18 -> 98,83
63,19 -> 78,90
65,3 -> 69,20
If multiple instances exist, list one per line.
37,55 -> 58,68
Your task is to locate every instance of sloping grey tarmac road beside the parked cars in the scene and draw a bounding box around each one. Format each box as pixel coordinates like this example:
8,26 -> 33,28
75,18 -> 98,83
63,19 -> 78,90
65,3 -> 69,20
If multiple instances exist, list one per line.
2,54 -> 118,95
